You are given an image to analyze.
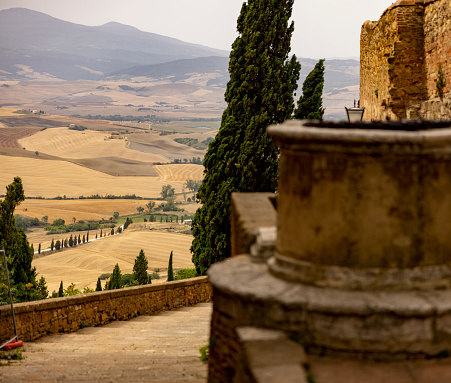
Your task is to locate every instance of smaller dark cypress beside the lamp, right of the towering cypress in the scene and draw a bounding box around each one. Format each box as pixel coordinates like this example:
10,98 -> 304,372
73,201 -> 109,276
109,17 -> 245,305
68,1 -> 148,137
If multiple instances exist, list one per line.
294,60 -> 325,120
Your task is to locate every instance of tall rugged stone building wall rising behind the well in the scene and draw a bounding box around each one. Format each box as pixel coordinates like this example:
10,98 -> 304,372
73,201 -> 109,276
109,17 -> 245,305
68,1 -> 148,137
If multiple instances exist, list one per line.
360,0 -> 451,121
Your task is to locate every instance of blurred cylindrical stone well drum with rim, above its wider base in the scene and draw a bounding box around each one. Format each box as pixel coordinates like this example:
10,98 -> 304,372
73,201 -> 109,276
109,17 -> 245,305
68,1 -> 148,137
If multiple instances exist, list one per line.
268,121 -> 451,290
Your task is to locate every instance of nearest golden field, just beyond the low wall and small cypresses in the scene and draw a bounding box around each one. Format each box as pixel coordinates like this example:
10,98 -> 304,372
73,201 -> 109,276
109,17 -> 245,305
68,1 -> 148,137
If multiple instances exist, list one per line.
33,225 -> 193,293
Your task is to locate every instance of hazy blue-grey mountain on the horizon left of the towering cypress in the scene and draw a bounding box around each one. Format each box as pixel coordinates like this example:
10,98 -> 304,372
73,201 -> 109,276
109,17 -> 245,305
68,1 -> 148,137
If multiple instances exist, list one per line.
0,8 -> 228,80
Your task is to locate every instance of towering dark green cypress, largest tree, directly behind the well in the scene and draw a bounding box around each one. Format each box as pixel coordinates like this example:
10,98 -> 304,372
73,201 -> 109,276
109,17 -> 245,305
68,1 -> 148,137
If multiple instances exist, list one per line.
191,0 -> 300,275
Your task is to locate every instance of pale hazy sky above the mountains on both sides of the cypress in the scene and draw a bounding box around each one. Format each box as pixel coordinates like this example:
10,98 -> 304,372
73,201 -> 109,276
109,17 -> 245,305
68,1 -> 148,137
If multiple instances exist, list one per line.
0,0 -> 392,58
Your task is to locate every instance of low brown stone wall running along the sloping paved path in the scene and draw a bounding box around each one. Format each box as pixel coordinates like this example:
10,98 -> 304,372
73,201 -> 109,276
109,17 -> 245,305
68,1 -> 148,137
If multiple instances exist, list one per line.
0,277 -> 212,341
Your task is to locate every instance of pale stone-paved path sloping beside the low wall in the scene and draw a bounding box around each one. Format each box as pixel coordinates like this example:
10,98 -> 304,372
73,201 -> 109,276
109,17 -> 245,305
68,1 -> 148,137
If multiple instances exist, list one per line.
0,303 -> 212,383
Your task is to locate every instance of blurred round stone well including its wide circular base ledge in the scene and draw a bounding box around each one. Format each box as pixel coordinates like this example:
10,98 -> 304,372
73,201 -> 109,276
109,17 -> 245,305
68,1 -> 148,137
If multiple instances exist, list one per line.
208,121 -> 451,372
